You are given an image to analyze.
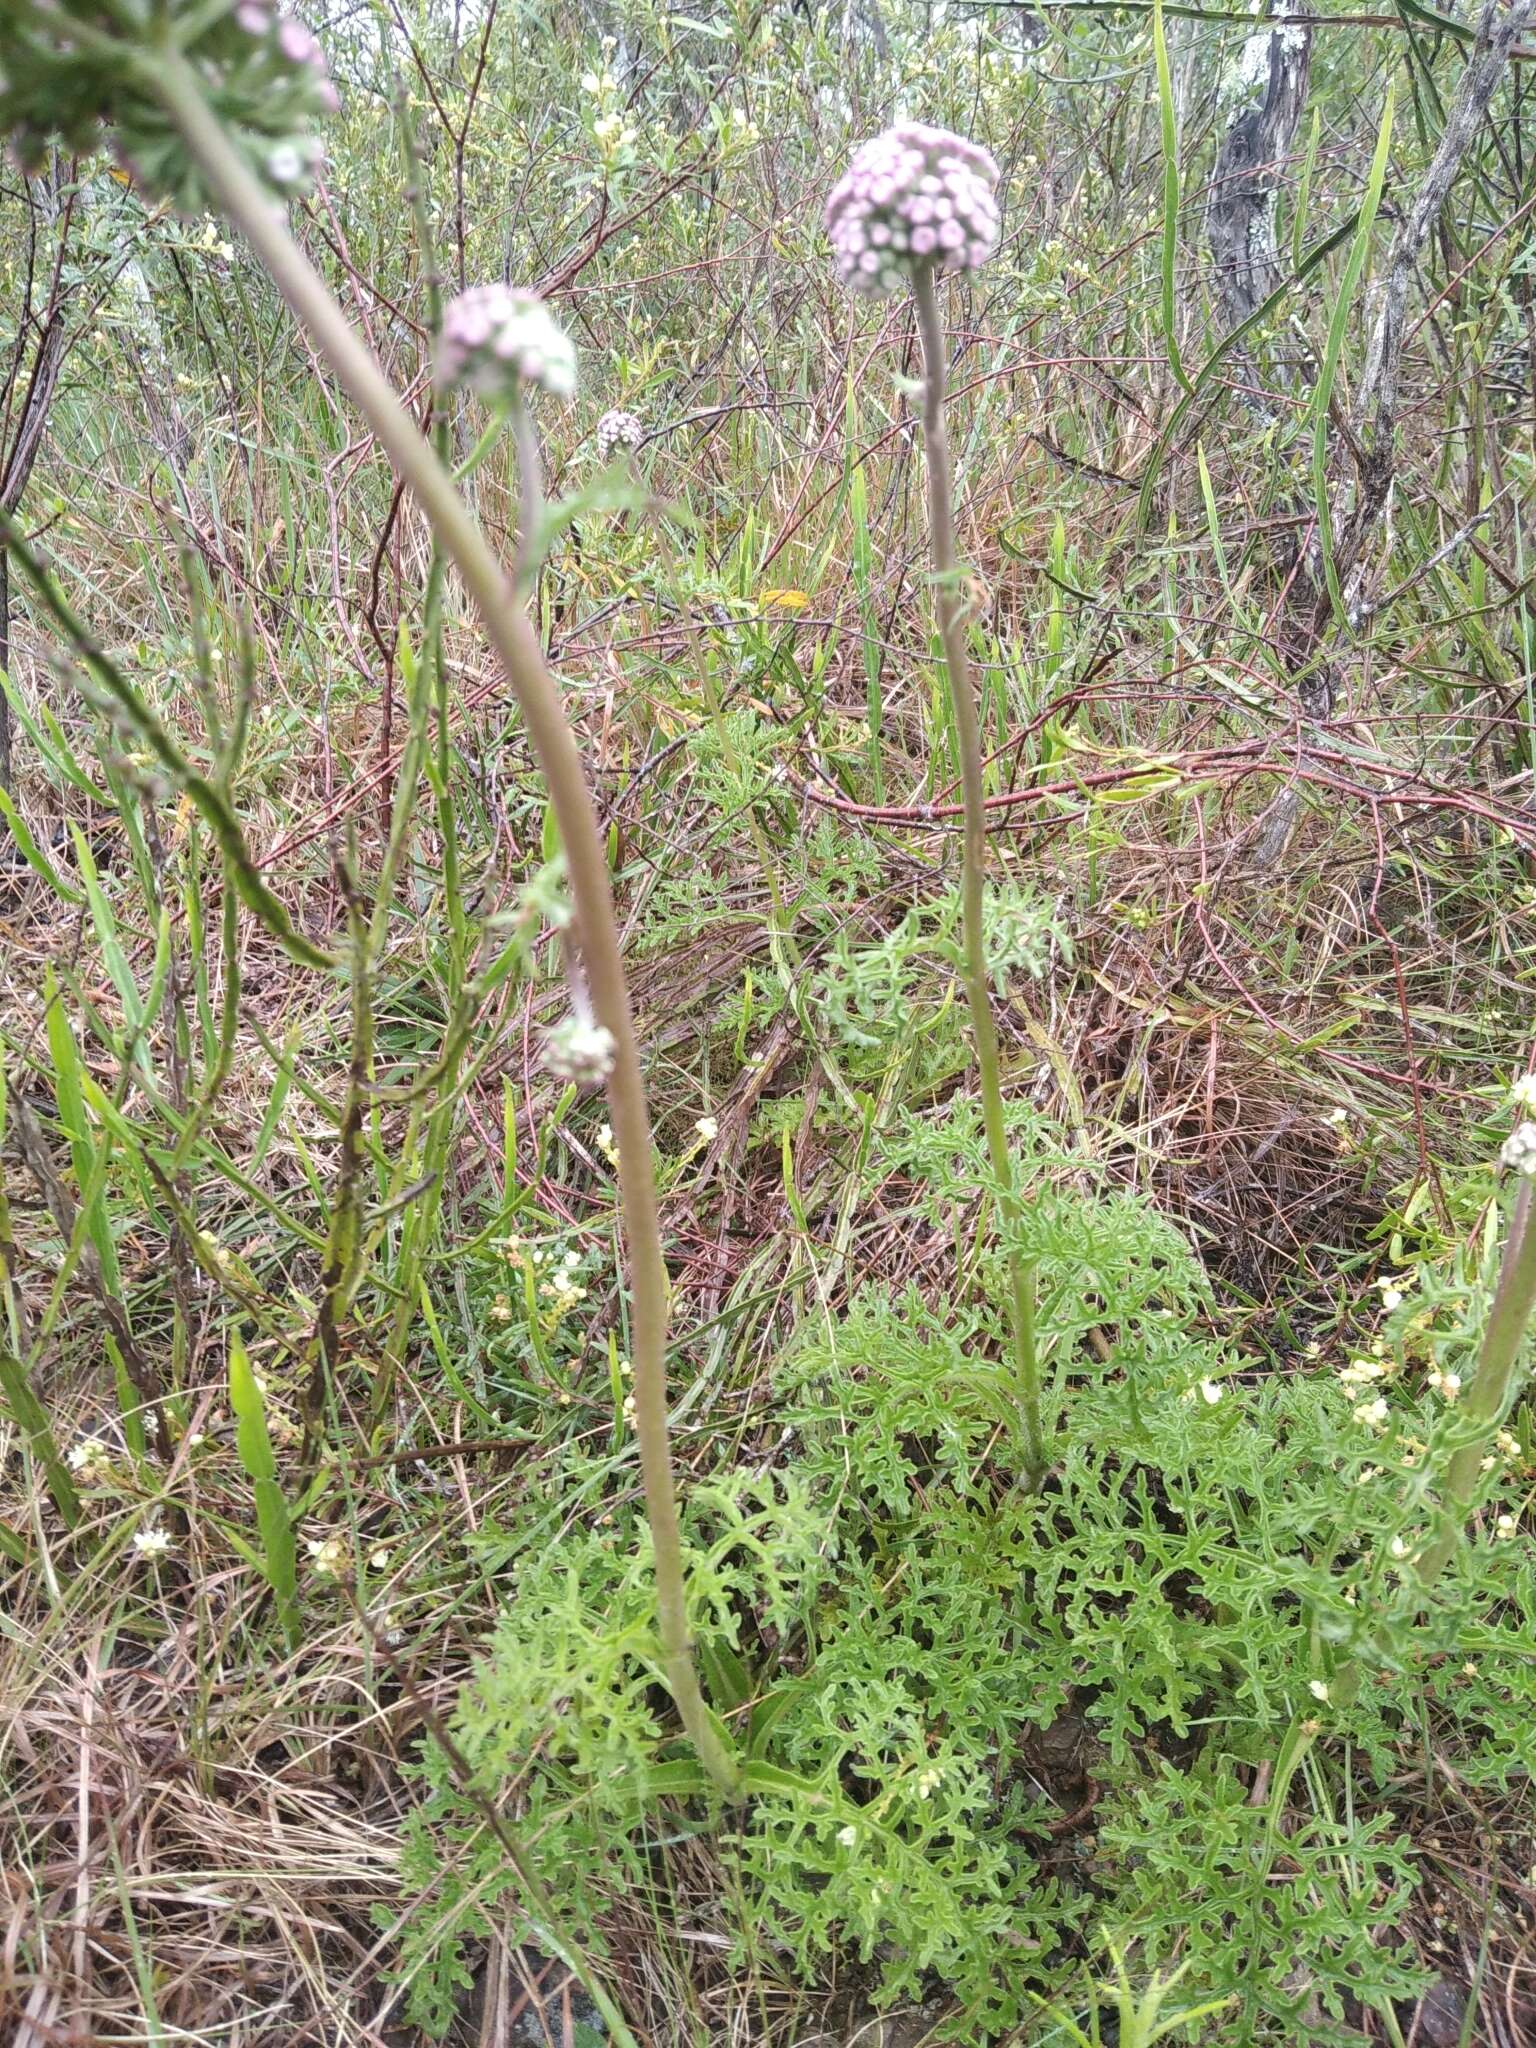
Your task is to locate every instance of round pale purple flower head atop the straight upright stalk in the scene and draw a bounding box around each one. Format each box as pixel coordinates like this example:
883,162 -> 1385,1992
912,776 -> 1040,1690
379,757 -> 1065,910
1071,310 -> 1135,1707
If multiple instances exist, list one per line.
827,121 -> 997,293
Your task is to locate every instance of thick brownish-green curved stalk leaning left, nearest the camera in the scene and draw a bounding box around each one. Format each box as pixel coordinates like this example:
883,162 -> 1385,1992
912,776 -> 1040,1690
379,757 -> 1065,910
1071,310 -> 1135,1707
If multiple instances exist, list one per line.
145,43 -> 737,1792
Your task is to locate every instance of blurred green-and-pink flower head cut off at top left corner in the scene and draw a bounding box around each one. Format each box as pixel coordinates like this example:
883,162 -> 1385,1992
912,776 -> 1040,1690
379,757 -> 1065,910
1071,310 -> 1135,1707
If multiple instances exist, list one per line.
0,0 -> 338,213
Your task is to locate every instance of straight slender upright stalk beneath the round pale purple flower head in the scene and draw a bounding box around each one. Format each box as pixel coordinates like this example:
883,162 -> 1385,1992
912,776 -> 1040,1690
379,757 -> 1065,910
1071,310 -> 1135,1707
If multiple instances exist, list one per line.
911,264 -> 1049,1485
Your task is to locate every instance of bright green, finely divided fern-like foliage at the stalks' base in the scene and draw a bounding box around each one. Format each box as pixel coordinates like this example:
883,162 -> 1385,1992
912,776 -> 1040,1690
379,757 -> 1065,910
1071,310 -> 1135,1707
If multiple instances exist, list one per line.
397,1104 -> 1536,2044
